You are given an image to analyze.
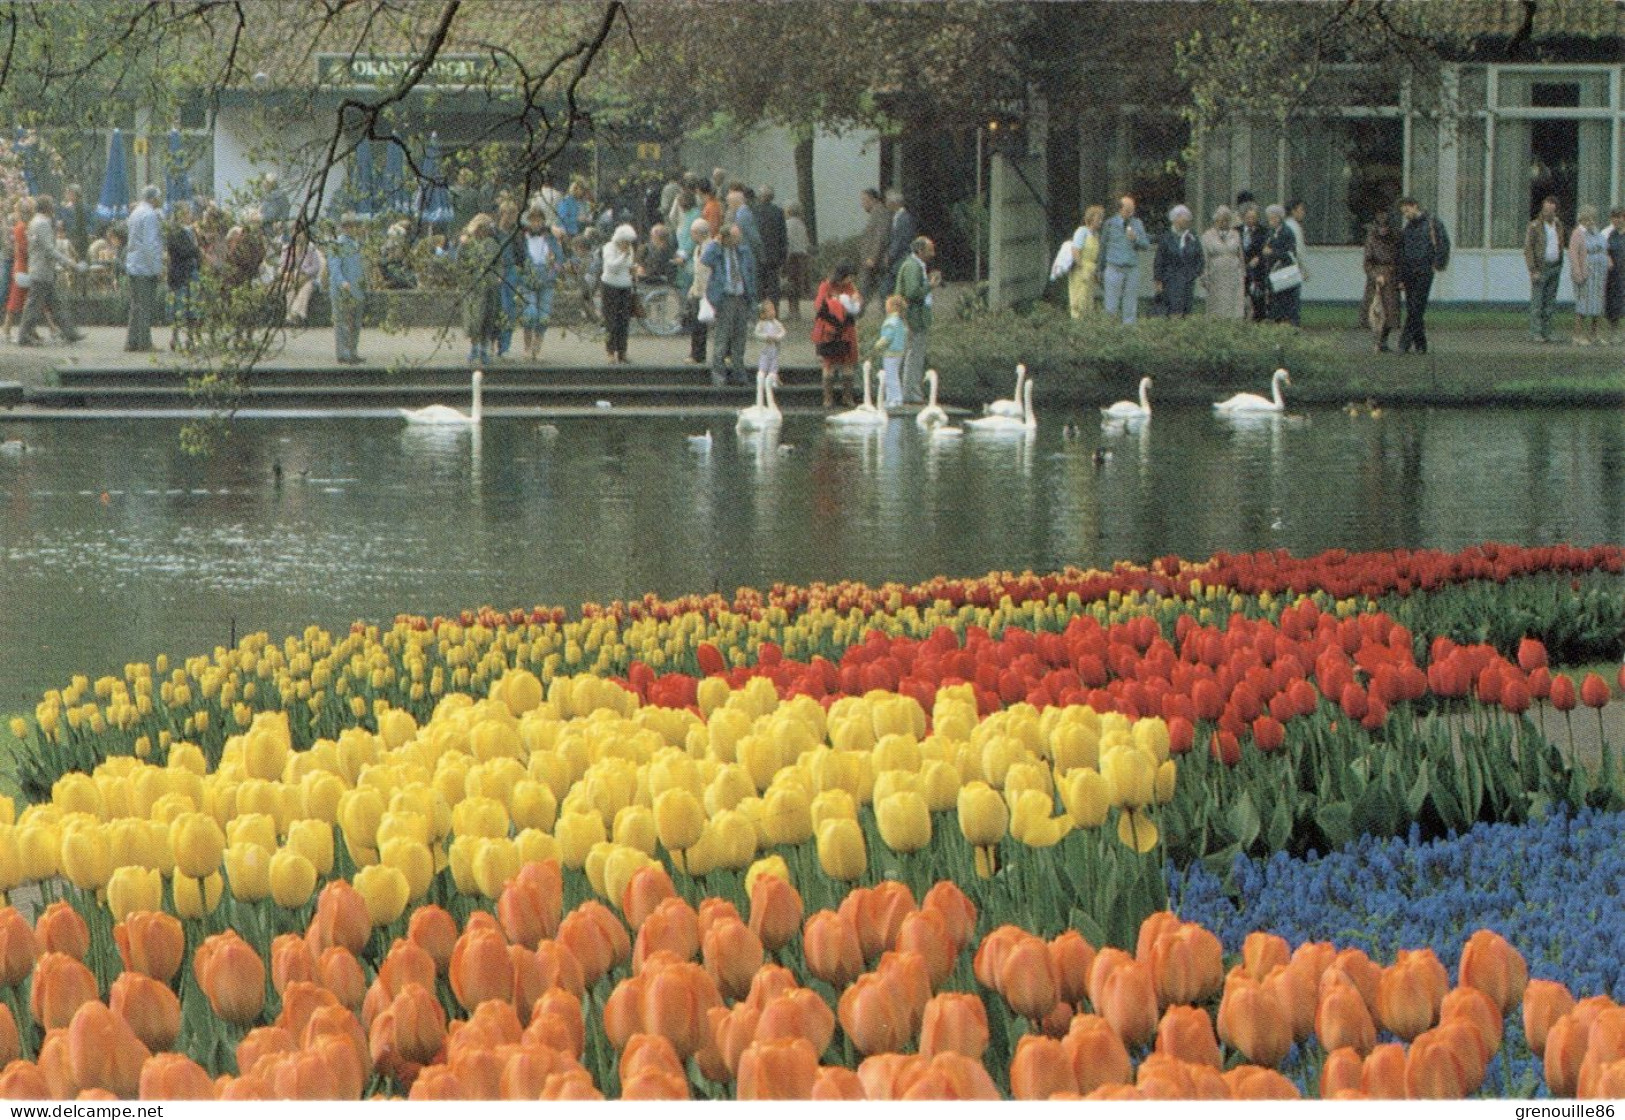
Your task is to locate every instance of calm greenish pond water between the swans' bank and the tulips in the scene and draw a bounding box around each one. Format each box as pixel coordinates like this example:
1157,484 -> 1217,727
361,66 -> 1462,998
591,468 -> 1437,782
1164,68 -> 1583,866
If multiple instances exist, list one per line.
0,408 -> 1625,712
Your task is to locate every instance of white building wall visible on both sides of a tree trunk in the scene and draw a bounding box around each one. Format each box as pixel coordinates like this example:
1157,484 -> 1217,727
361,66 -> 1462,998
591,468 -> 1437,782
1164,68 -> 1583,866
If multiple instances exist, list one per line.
683,128 -> 881,241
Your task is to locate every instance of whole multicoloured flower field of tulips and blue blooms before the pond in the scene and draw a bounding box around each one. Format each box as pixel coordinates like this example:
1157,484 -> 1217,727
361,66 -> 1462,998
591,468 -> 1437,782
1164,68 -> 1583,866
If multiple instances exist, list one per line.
0,545 -> 1625,1100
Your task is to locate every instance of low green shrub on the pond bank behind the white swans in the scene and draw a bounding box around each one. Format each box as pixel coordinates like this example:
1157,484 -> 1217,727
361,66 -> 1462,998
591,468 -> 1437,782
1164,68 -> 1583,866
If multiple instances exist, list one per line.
931,304 -> 1337,402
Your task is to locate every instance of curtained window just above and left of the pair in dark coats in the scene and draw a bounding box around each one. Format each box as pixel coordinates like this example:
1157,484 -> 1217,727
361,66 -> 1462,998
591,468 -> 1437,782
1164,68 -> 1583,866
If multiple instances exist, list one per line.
1287,117 -> 1404,245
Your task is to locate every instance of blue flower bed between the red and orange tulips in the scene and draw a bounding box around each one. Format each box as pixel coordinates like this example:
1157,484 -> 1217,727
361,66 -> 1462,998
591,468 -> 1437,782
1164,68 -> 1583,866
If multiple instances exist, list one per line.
1168,810 -> 1625,1097
